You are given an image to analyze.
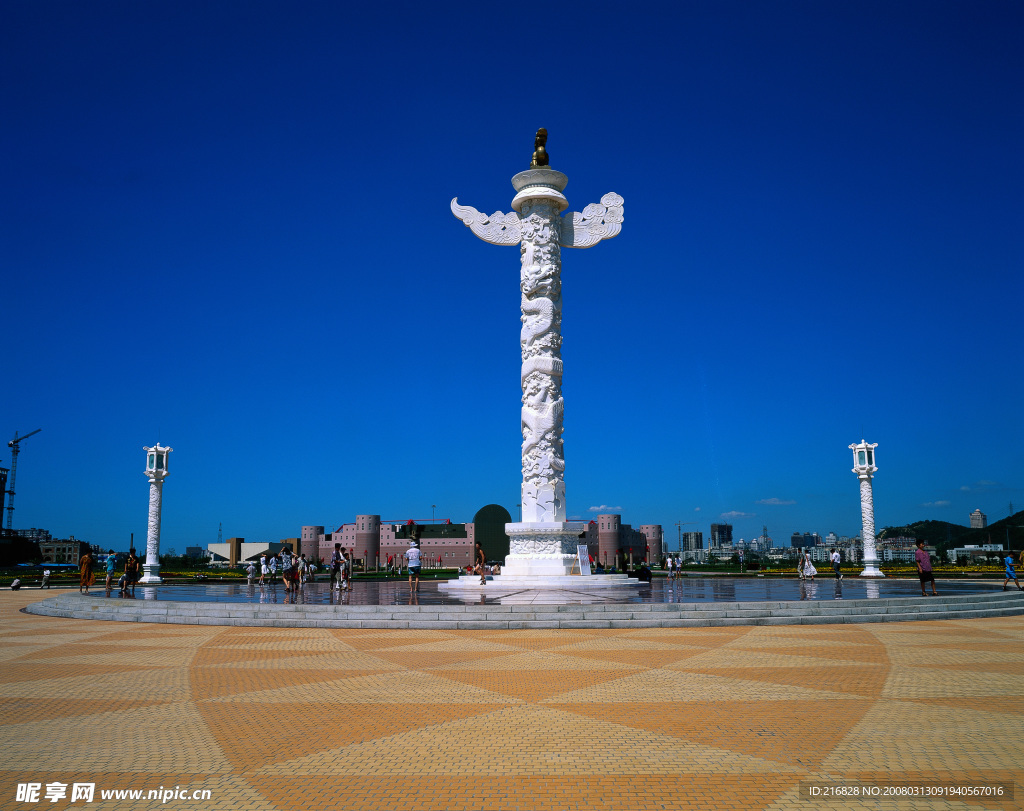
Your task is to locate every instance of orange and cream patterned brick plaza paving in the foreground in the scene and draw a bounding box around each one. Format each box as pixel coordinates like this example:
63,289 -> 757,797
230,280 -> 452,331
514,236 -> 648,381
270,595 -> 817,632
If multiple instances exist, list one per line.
0,591 -> 1024,811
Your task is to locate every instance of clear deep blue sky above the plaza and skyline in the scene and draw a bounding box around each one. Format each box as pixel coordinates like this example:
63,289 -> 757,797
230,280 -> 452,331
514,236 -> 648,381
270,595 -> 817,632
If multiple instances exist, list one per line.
0,0 -> 1024,551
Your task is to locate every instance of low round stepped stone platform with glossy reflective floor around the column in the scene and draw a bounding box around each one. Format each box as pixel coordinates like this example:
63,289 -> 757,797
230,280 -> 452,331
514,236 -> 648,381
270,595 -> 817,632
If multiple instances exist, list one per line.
26,578 -> 1024,630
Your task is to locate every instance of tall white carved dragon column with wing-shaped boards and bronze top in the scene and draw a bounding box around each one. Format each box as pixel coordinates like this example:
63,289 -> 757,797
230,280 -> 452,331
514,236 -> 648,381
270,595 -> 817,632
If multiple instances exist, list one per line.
452,129 -> 623,579
